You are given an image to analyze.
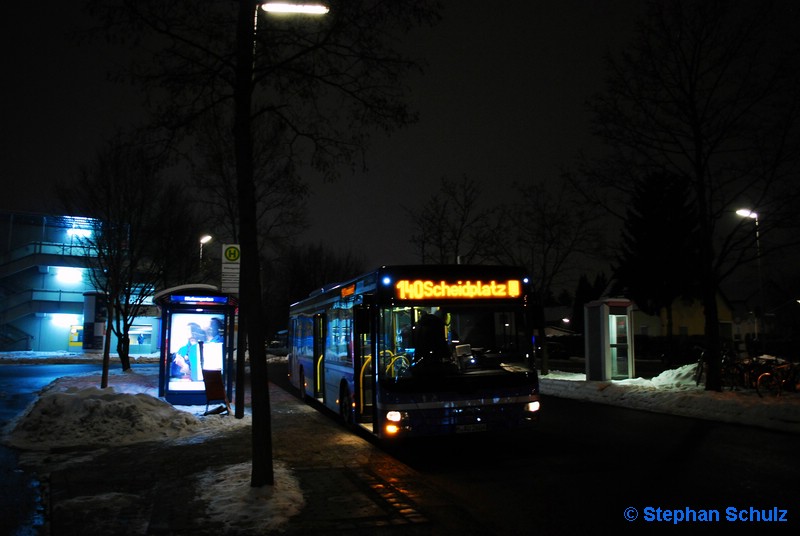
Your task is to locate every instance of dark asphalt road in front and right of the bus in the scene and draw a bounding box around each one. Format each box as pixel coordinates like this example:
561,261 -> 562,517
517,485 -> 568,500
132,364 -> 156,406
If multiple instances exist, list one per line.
270,365 -> 800,535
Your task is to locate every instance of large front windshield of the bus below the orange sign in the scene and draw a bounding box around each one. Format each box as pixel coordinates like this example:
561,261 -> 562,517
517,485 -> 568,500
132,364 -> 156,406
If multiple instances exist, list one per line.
379,306 -> 532,381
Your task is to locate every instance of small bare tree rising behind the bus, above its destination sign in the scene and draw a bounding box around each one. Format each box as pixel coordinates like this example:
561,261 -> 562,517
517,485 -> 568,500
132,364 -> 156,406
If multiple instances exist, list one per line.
405,175 -> 489,264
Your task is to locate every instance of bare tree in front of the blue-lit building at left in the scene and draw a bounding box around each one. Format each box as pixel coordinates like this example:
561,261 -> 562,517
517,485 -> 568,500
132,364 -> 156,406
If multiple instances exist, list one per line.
59,135 -> 196,387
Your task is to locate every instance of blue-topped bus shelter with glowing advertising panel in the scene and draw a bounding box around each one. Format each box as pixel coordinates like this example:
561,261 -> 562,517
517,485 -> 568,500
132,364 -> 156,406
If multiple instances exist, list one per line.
153,284 -> 237,406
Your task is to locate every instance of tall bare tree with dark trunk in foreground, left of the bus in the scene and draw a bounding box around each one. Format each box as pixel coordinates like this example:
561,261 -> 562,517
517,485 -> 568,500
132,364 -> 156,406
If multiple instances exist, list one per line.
84,0 -> 438,486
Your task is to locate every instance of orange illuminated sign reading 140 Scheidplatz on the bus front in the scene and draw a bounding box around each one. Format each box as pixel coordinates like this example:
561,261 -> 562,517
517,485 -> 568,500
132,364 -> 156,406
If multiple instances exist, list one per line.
395,279 -> 522,300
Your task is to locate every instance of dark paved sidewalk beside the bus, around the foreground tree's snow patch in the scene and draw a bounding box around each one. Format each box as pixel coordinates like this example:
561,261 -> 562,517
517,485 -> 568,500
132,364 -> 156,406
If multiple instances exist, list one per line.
44,385 -> 492,536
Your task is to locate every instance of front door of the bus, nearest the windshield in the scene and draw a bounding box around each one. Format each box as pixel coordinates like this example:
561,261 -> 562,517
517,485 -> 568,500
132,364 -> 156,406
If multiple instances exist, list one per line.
353,305 -> 376,423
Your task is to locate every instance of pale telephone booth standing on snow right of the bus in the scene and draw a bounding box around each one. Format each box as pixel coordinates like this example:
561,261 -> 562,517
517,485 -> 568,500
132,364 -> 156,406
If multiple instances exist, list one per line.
584,298 -> 634,380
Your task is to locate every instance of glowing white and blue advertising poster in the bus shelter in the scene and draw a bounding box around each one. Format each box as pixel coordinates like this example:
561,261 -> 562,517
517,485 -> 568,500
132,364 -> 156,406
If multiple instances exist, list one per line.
167,312 -> 225,391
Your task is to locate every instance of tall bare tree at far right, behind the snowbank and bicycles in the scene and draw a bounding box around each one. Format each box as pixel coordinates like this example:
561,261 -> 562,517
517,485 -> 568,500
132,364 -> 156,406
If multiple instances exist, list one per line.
582,0 -> 800,390
